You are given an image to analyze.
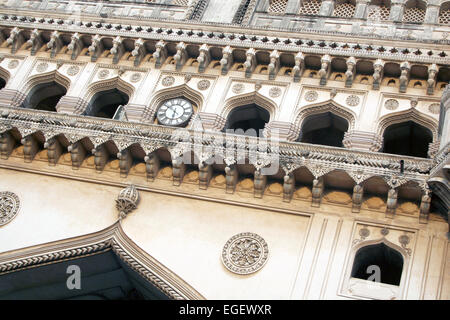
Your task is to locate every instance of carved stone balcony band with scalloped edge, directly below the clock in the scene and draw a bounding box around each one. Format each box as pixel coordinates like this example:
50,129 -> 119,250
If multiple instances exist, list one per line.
0,107 -> 433,185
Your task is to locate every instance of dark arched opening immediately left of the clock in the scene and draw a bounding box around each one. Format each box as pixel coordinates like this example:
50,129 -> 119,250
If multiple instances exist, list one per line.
87,89 -> 129,119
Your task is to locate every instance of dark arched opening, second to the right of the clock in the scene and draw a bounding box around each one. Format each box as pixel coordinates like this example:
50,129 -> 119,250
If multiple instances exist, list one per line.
298,112 -> 348,147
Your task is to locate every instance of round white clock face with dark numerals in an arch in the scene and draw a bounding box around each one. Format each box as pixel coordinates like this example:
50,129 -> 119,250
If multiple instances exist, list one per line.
156,98 -> 194,126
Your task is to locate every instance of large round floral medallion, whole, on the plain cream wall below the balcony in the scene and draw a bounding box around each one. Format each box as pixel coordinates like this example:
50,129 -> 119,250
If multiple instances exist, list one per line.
222,232 -> 269,274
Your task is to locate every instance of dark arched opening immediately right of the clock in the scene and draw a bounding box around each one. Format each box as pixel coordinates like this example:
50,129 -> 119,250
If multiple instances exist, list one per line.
225,103 -> 270,137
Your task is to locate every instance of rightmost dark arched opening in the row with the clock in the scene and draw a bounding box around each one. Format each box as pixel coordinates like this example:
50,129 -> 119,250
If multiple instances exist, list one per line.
383,121 -> 433,158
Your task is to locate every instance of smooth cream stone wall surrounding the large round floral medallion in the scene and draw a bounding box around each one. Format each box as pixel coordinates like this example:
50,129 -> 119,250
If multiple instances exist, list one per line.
0,168 -> 450,299
